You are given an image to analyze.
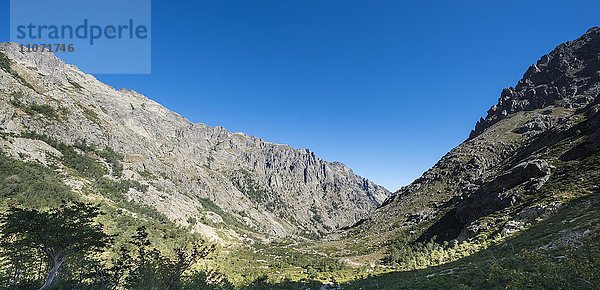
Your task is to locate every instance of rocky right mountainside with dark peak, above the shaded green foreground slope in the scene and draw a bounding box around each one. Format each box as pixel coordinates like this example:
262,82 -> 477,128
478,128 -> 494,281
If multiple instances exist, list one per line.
346,28 -> 600,243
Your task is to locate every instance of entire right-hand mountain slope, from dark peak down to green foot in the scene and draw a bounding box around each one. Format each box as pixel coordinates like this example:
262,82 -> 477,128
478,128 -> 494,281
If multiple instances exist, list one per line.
225,28 -> 600,289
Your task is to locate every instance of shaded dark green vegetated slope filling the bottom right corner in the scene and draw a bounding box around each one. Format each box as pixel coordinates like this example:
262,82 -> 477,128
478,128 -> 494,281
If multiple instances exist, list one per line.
344,196 -> 600,289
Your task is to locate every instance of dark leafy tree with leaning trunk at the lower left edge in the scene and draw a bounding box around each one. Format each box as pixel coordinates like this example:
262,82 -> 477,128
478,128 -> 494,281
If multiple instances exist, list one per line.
0,202 -> 111,289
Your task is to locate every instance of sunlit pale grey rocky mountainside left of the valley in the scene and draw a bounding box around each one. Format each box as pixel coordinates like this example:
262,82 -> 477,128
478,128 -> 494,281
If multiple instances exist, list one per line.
0,43 -> 389,236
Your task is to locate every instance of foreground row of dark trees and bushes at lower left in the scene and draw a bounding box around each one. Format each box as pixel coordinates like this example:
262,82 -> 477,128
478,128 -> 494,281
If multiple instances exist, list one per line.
0,202 -> 225,289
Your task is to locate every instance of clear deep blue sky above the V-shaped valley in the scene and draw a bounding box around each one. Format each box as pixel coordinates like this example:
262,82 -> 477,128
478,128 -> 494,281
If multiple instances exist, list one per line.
0,0 -> 600,190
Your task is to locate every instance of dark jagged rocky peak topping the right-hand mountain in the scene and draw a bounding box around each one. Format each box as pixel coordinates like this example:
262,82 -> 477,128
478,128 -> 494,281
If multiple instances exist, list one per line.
469,27 -> 600,139
